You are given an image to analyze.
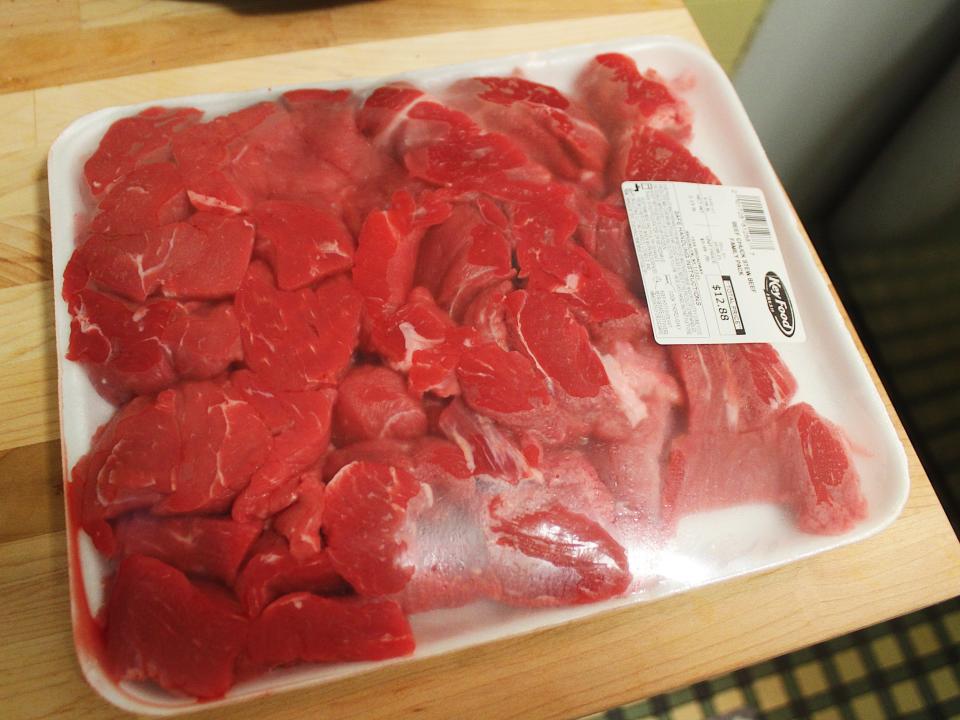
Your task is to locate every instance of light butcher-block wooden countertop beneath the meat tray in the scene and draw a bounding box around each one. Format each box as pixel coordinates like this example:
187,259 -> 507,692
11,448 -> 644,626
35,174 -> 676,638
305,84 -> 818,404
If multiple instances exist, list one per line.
0,0 -> 960,719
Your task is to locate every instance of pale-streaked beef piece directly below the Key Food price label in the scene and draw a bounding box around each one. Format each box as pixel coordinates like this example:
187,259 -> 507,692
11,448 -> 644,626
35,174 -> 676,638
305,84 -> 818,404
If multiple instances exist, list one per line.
670,344 -> 797,432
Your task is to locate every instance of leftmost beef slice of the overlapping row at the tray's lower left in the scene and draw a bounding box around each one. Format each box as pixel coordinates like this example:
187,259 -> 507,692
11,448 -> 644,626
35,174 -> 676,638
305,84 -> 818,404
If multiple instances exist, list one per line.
71,390 -> 180,555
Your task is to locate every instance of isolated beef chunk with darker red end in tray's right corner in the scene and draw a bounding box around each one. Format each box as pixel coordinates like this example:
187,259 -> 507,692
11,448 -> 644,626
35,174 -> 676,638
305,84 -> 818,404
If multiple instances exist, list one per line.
663,403 -> 866,535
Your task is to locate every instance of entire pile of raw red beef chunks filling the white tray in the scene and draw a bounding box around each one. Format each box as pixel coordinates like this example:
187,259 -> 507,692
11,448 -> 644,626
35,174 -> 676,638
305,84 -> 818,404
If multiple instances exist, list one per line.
63,54 -> 866,700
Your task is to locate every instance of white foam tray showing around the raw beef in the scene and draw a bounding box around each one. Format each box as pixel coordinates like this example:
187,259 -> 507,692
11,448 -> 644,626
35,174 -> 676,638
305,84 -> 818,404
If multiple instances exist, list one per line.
49,37 -> 909,715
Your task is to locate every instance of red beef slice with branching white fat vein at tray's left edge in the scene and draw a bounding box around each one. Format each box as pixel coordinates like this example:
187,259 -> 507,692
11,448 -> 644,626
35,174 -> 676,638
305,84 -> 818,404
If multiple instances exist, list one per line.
74,213 -> 253,302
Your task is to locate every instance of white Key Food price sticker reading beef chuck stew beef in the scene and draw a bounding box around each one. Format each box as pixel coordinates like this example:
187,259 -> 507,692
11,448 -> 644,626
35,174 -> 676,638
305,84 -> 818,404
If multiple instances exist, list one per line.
622,181 -> 805,345
